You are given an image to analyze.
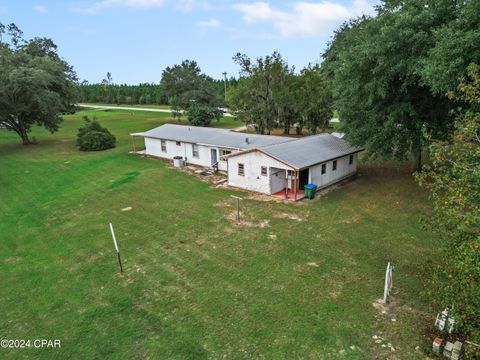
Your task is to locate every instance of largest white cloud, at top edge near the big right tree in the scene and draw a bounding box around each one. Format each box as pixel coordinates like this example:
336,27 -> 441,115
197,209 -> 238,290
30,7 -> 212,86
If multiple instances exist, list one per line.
233,0 -> 373,38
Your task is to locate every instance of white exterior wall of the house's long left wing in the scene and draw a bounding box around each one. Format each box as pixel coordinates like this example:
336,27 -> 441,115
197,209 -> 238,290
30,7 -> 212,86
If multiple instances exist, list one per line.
145,137 -> 237,172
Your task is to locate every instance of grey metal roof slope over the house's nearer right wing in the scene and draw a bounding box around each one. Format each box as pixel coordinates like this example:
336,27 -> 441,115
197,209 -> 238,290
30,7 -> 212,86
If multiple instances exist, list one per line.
258,134 -> 363,169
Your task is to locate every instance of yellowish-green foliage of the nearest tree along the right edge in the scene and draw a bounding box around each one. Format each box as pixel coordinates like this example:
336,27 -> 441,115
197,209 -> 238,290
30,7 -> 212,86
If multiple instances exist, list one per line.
417,64 -> 480,357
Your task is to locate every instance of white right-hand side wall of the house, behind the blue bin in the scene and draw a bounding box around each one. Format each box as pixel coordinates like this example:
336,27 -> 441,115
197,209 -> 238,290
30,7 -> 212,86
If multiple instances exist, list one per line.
309,154 -> 358,188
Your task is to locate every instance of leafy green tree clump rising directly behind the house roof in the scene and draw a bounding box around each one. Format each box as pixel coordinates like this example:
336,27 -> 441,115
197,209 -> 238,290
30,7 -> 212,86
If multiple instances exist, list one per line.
228,52 -> 332,134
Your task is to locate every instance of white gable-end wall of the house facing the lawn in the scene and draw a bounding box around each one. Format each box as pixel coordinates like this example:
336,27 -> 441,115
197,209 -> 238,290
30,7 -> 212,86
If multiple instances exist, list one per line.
228,151 -> 292,195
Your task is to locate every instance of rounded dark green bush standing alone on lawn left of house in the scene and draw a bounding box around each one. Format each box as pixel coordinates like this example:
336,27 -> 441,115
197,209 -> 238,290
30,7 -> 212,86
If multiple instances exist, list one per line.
77,116 -> 116,151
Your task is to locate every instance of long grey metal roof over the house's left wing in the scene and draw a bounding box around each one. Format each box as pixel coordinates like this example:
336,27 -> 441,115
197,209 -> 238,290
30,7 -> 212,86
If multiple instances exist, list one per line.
131,124 -> 296,150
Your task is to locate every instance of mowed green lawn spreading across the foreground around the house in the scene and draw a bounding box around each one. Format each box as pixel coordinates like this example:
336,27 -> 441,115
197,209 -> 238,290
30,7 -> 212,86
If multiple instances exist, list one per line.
0,111 -> 436,359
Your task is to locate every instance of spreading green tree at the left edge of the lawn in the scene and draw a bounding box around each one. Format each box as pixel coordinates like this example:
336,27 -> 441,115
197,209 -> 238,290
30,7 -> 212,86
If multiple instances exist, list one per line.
0,24 -> 76,145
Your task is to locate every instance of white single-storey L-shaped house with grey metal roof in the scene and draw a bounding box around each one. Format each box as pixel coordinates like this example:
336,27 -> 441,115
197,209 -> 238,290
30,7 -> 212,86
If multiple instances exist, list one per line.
132,124 -> 363,199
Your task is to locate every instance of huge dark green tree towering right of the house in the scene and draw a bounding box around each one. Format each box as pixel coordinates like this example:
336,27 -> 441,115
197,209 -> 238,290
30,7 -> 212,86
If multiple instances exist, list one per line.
322,0 -> 480,168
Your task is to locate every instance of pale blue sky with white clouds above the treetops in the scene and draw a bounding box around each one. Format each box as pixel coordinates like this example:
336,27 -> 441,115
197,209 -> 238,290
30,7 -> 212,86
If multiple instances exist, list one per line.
0,0 -> 379,84
